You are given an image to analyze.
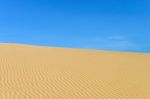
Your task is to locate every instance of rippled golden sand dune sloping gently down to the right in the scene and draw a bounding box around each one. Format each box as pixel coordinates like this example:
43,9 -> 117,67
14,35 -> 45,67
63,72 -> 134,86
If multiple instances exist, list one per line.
0,44 -> 150,99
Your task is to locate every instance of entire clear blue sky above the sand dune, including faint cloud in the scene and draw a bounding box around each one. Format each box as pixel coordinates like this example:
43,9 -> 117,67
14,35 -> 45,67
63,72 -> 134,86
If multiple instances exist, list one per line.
0,0 -> 150,52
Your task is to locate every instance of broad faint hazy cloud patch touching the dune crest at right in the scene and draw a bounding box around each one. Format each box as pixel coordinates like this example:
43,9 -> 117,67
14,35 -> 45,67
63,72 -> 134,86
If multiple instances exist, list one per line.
81,35 -> 140,51
